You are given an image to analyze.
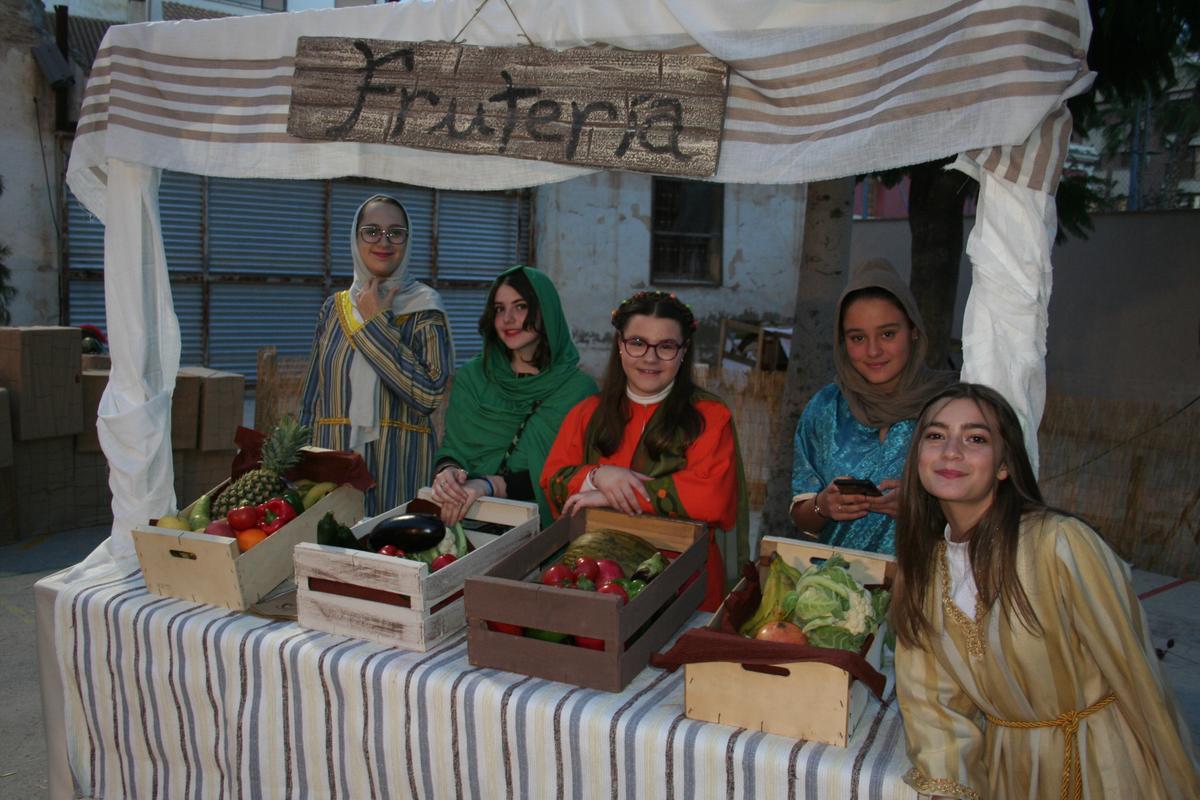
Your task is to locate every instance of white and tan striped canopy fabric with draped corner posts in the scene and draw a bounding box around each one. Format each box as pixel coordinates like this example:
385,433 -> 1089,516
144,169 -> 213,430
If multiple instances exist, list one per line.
67,0 -> 1092,569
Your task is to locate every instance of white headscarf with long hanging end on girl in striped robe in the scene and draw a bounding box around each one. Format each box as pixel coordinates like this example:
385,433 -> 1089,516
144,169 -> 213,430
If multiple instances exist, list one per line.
350,194 -> 446,450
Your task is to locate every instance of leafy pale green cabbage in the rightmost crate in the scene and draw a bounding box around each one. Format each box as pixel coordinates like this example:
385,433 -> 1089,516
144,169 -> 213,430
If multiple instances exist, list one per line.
784,553 -> 888,652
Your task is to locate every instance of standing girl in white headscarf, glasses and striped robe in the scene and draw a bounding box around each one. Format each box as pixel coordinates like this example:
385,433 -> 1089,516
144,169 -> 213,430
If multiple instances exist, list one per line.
300,194 -> 452,516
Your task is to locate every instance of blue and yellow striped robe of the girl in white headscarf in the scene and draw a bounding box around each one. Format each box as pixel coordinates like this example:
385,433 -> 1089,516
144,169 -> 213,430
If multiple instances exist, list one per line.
300,291 -> 452,517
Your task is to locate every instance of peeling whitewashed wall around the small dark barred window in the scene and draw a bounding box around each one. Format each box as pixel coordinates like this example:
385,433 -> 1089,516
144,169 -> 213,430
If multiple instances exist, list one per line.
534,173 -> 805,374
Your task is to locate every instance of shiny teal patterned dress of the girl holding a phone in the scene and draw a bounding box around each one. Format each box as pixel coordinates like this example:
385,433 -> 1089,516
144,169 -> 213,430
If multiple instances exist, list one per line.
792,384 -> 917,554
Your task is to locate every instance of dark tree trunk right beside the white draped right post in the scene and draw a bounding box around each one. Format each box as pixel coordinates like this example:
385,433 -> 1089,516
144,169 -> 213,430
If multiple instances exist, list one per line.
908,161 -> 971,369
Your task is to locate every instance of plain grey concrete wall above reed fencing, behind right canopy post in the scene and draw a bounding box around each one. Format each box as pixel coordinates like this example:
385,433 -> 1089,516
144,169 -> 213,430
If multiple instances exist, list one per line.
851,211 -> 1200,405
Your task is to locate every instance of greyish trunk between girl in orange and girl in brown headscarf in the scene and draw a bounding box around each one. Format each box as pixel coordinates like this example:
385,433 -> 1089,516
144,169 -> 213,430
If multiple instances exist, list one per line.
762,178 -> 854,535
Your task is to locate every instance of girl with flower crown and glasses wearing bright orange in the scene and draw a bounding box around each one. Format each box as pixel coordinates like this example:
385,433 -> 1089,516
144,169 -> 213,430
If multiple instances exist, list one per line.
541,291 -> 750,610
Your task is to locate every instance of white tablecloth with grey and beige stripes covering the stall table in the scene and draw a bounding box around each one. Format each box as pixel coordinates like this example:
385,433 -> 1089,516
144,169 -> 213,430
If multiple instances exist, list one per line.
55,572 -> 916,800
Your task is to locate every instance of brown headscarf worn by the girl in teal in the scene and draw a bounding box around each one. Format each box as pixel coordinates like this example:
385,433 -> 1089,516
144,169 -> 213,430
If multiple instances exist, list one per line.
833,258 -> 958,428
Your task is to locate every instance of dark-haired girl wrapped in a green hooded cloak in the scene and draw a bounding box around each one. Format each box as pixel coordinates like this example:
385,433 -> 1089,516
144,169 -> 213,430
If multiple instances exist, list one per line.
432,266 -> 596,524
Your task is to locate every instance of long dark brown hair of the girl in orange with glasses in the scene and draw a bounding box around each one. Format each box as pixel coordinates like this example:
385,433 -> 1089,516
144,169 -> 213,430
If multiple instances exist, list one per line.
594,291 -> 704,459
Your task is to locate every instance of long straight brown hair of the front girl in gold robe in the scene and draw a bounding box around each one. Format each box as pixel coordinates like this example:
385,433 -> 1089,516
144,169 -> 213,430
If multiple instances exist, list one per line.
890,384 -> 1048,648
